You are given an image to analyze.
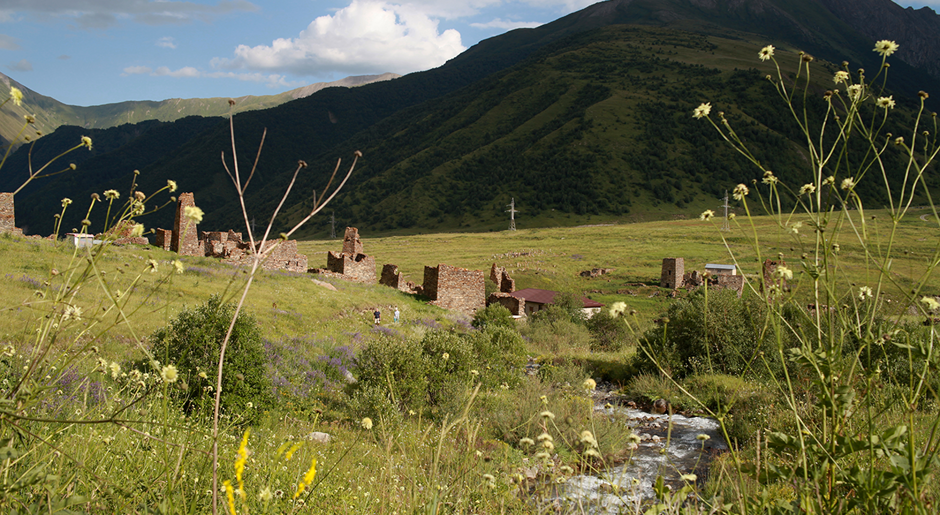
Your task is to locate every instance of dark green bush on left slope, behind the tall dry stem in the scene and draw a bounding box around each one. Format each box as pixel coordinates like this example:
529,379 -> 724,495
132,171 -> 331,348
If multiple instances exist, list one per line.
150,295 -> 274,419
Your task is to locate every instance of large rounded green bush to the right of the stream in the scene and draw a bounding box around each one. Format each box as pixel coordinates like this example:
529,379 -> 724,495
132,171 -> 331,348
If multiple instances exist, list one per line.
634,290 -> 780,377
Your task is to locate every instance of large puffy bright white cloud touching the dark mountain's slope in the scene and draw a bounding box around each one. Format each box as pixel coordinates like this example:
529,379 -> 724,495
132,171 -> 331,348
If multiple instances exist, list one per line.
213,0 -> 465,75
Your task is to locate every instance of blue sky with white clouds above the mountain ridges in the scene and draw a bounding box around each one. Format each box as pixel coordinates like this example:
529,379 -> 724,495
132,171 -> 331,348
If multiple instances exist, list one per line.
0,0 -> 940,106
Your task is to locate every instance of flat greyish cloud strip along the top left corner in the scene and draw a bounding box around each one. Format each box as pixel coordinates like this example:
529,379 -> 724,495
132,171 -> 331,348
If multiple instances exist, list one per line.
0,0 -> 258,29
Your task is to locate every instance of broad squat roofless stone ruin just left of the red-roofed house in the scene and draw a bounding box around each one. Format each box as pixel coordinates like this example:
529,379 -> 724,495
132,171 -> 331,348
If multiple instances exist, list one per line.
424,264 -> 486,315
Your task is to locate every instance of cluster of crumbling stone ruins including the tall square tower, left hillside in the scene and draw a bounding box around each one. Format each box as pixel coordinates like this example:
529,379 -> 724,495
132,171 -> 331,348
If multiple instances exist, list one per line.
154,193 -> 307,273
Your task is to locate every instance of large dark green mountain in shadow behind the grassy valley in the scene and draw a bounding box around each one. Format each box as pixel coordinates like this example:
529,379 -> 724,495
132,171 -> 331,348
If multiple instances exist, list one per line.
0,0 -> 938,236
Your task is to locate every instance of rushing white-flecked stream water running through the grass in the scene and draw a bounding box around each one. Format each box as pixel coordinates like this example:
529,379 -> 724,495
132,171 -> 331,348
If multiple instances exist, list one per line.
564,406 -> 728,514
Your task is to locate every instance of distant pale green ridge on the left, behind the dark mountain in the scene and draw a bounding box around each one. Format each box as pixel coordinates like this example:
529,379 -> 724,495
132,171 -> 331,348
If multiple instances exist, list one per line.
0,73 -> 399,151
